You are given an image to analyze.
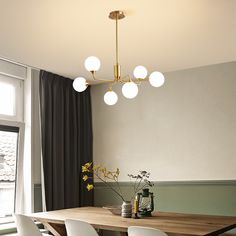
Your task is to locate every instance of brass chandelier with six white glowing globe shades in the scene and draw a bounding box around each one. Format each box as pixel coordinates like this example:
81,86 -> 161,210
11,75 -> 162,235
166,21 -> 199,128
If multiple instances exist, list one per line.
73,11 -> 165,105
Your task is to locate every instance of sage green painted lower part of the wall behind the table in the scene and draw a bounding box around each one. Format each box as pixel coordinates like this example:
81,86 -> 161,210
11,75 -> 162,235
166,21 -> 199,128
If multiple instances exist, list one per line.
95,181 -> 236,236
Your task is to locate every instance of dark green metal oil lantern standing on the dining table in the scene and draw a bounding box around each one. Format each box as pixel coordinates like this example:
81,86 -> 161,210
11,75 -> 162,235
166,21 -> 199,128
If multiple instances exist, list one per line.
138,188 -> 154,216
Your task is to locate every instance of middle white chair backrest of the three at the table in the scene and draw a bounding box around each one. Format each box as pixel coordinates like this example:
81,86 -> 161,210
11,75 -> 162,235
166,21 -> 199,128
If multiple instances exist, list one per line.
65,219 -> 98,236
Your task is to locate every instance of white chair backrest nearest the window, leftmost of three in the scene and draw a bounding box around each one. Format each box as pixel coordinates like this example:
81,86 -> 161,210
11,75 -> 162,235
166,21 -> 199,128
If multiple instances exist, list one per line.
15,214 -> 42,236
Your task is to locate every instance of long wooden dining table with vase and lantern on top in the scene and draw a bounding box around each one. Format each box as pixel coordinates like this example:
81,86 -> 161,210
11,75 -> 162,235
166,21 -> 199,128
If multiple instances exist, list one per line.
29,207 -> 236,236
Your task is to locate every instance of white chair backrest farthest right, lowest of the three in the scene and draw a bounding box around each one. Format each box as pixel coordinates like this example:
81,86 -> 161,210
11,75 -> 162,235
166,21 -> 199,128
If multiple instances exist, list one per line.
128,226 -> 167,236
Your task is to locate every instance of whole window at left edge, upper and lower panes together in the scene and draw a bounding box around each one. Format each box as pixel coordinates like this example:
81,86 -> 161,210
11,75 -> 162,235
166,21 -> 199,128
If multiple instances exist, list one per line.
0,72 -> 24,224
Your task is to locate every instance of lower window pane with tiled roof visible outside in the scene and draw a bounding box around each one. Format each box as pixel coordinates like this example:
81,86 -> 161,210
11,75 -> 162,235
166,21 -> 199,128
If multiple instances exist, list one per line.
0,125 -> 19,223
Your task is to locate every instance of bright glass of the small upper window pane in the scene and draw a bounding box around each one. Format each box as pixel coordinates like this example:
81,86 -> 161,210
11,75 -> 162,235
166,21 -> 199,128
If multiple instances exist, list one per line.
0,82 -> 15,116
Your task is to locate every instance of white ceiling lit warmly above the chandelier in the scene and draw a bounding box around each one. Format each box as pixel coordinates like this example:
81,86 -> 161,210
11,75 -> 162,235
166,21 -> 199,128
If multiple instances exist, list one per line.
0,0 -> 236,79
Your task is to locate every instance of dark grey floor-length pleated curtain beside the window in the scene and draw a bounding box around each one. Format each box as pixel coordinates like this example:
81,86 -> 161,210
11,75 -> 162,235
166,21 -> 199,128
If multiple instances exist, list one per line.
40,71 -> 93,211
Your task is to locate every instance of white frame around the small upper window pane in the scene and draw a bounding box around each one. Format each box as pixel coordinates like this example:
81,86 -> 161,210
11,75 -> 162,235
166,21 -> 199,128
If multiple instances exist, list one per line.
0,73 -> 24,122
